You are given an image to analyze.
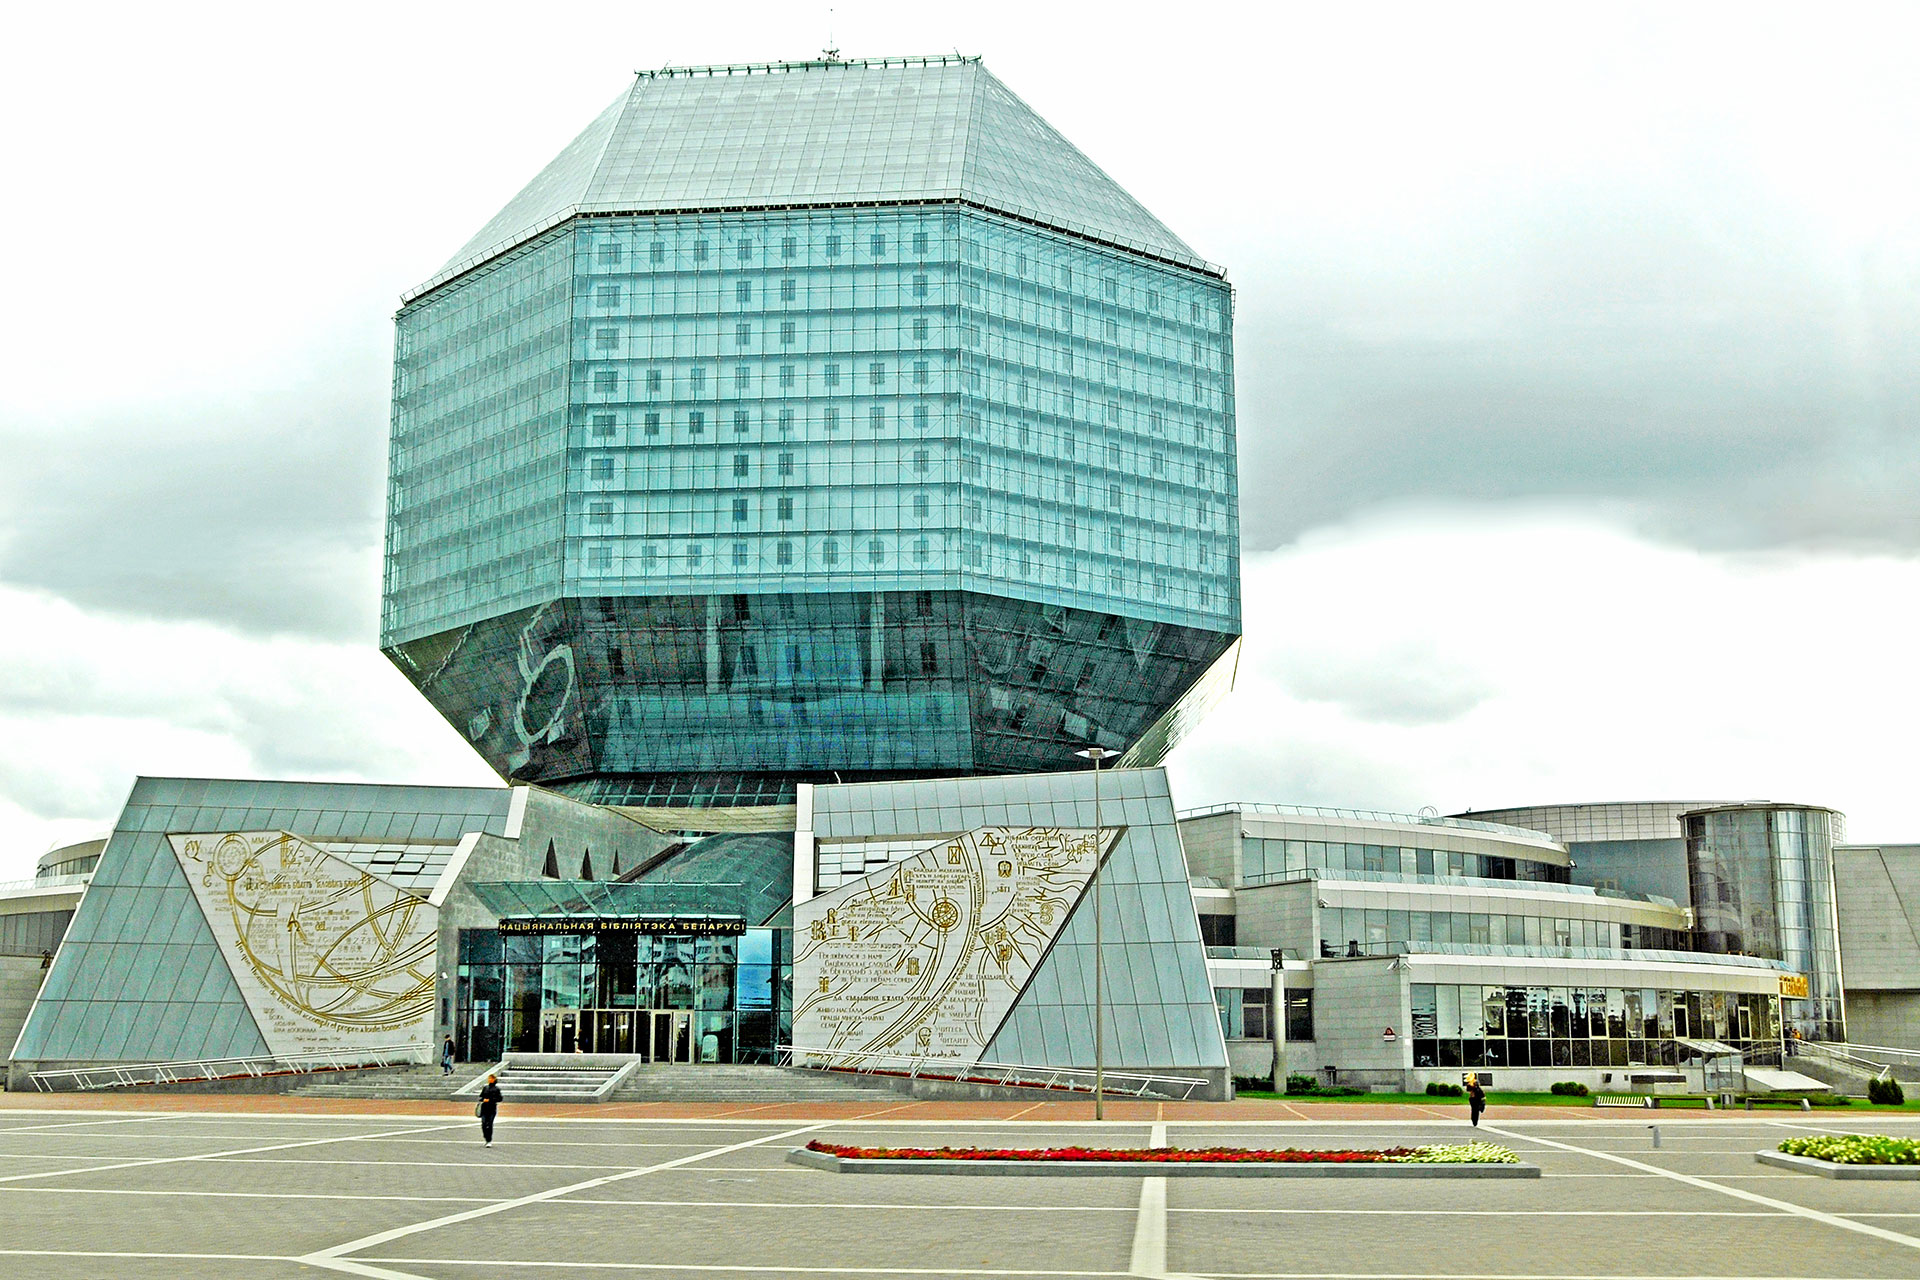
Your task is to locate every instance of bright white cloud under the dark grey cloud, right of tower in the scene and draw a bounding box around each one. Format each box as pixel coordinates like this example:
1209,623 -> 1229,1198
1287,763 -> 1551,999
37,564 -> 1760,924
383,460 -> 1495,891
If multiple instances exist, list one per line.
1173,510 -> 1920,841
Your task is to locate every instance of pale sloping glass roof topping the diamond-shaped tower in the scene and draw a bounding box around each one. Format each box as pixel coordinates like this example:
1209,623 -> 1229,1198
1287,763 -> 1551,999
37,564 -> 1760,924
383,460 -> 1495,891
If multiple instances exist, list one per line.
407,56 -> 1219,301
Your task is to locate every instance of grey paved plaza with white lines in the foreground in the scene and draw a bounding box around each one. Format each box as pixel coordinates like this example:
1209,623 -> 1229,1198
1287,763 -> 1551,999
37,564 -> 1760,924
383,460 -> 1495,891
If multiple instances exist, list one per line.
0,1096 -> 1920,1280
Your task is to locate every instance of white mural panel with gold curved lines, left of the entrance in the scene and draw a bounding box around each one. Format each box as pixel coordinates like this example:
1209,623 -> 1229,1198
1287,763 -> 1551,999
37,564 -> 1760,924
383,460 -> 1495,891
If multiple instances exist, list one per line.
167,831 -> 440,1054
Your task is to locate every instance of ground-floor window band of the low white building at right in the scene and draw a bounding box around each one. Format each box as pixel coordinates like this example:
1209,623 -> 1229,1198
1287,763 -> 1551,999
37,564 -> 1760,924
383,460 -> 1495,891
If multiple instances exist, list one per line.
1407,983 -> 1780,1067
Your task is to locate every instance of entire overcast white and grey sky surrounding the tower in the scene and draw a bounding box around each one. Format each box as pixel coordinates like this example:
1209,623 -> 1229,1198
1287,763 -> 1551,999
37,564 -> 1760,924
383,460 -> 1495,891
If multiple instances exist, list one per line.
0,0 -> 1920,879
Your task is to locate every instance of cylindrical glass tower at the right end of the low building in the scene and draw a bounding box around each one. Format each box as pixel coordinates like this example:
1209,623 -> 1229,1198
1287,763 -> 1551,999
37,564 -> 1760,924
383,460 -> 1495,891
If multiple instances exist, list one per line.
1682,806 -> 1847,1040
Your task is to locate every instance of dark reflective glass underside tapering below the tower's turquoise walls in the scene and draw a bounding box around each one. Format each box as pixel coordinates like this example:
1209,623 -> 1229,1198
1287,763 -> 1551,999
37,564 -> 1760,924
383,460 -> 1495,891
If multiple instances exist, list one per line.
390,591 -> 1229,790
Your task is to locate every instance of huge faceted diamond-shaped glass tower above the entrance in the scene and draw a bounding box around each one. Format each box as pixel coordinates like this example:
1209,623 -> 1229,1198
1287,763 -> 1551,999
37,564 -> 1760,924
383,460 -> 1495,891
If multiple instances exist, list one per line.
382,58 -> 1240,806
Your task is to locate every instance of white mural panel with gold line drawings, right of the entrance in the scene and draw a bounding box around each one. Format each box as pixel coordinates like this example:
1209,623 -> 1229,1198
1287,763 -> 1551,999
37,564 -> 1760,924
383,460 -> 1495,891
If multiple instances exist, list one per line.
793,827 -> 1117,1065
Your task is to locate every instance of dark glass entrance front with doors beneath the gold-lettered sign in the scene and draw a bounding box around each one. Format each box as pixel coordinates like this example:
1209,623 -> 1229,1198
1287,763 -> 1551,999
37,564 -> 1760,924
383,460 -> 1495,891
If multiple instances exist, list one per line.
455,929 -> 791,1063
